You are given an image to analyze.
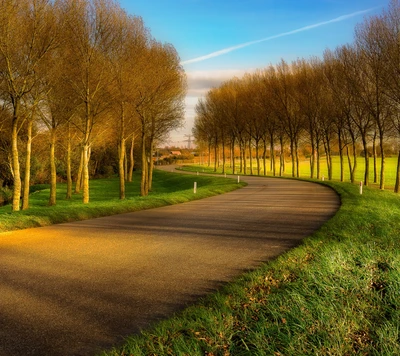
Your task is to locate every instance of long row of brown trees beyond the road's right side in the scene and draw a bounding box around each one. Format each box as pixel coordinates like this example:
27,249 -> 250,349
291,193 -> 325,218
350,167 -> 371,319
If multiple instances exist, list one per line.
193,0 -> 400,192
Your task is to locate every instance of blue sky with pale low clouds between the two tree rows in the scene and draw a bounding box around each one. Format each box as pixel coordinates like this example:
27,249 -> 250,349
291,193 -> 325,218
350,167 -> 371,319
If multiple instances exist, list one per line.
120,0 -> 390,147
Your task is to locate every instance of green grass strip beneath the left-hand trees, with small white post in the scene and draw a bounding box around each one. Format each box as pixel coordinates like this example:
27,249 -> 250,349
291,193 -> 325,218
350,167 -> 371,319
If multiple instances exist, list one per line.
0,170 -> 242,232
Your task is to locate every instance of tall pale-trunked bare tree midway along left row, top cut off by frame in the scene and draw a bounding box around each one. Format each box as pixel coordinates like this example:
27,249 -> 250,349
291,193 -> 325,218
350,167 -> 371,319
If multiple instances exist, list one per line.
59,0 -> 116,204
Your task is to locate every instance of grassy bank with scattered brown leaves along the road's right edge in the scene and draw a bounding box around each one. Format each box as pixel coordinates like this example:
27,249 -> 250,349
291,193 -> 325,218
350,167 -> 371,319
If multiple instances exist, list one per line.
103,172 -> 400,356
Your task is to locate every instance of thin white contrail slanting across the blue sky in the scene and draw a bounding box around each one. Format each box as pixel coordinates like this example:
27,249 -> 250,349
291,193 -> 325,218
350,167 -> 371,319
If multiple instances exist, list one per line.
181,7 -> 376,64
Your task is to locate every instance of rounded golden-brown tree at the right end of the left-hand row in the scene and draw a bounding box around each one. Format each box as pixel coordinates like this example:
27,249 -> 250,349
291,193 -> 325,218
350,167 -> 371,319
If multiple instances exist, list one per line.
134,40 -> 186,196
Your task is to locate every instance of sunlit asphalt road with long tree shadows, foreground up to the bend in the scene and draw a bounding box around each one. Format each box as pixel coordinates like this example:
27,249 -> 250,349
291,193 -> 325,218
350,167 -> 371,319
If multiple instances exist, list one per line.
0,171 -> 340,356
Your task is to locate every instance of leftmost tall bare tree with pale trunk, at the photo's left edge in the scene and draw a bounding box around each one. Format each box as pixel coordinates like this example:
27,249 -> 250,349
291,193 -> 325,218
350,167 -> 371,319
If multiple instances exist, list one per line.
0,0 -> 55,211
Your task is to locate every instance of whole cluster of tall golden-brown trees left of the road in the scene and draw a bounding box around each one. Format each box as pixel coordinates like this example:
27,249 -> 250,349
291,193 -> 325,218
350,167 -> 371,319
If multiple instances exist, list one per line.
0,0 -> 186,211
